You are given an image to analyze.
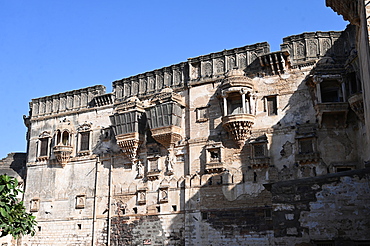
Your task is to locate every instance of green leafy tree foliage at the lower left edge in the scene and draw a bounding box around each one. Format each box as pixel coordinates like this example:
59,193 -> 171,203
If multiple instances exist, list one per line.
0,175 -> 36,238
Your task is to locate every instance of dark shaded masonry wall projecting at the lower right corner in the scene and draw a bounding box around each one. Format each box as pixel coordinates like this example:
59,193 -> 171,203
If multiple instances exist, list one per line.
271,169 -> 370,245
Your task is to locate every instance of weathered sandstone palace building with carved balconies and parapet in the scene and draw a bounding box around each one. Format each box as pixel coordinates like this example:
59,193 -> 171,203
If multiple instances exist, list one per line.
1,0 -> 370,245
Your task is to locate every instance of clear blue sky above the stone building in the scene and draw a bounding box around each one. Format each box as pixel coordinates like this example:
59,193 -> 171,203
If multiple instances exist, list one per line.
0,0 -> 347,158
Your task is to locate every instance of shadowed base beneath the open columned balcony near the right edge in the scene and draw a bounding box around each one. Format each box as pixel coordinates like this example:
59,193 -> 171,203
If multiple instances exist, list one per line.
315,102 -> 348,127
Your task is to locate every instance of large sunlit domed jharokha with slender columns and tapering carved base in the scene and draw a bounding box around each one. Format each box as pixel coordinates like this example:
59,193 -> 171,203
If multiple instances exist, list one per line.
220,69 -> 256,148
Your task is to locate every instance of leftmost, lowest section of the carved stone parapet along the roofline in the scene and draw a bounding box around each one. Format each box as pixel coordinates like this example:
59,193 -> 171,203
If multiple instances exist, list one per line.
30,85 -> 105,118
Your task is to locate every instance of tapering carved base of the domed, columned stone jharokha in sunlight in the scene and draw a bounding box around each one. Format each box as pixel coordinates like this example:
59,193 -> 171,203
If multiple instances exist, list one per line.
222,114 -> 255,147
